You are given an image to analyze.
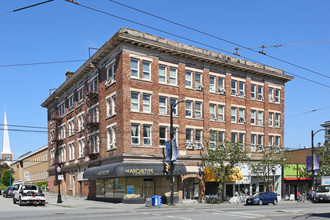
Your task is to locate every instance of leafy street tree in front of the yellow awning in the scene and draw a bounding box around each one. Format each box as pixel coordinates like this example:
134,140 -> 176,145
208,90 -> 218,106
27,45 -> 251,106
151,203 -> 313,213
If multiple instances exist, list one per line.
203,138 -> 249,202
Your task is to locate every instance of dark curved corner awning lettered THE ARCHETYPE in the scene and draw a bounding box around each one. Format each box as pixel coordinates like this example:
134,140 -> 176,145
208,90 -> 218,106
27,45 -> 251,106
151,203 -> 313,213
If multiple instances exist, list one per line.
83,163 -> 187,179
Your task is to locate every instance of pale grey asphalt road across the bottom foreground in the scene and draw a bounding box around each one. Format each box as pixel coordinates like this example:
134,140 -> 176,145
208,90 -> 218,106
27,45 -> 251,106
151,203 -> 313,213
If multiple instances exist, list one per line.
0,197 -> 330,220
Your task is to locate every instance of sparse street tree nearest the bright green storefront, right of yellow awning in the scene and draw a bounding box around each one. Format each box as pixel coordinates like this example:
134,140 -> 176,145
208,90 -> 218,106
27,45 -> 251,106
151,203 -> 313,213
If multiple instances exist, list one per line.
249,148 -> 288,191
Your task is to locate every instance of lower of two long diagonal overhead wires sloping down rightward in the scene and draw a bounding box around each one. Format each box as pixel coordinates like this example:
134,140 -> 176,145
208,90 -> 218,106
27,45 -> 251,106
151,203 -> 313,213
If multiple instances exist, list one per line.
63,1 -> 330,88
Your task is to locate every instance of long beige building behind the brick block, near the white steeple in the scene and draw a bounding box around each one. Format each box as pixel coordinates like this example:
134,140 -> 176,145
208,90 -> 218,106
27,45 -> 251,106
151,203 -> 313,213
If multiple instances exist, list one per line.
10,145 -> 49,183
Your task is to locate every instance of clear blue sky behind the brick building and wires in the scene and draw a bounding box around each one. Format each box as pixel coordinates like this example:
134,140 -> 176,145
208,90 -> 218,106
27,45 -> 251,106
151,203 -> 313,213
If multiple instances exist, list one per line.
0,0 -> 330,158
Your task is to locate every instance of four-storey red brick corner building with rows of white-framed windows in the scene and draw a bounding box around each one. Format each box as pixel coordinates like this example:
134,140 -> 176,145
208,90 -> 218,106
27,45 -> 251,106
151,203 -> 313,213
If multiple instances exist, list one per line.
42,28 -> 292,202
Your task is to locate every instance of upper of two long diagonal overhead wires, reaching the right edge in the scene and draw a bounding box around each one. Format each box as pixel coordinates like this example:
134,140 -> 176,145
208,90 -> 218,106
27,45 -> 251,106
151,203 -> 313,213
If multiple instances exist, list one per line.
109,0 -> 330,78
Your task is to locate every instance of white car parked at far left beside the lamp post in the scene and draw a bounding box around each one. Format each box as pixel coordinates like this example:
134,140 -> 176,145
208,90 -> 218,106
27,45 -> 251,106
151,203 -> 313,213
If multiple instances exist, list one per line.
13,184 -> 46,206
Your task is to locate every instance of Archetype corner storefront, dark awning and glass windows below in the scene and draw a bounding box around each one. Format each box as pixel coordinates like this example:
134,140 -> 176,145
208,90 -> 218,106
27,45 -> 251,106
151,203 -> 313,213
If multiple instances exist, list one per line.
84,163 -> 187,203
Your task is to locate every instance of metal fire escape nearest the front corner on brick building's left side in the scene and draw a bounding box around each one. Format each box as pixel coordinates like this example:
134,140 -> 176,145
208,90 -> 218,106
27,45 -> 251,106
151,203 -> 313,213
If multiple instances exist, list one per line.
84,78 -> 100,160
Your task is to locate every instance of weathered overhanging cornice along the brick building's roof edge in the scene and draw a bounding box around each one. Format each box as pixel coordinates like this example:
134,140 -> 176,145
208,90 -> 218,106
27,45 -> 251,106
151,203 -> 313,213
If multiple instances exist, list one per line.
41,28 -> 294,108
